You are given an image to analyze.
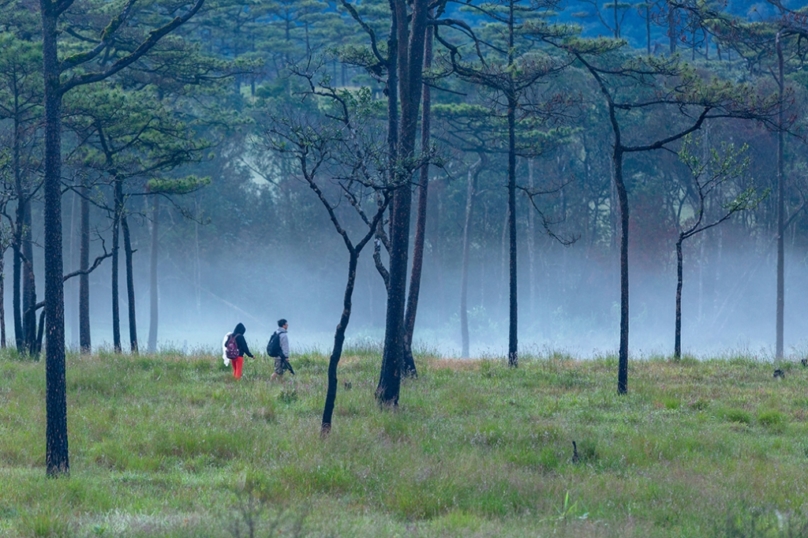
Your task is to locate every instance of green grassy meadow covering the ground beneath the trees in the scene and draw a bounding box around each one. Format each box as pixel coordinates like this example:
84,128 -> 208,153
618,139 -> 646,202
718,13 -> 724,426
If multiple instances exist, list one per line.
0,347 -> 808,537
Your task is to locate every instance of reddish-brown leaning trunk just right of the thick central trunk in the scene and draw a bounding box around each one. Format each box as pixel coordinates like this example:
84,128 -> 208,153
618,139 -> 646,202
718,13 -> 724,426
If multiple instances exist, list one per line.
403,22 -> 432,377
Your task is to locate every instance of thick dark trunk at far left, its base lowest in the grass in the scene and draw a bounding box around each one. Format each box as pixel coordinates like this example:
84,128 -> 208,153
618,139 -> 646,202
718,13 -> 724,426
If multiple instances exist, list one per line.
40,0 -> 70,476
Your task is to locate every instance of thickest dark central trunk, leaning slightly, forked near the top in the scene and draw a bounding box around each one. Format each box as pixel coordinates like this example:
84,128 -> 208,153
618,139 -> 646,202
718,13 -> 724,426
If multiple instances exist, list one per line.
376,0 -> 428,406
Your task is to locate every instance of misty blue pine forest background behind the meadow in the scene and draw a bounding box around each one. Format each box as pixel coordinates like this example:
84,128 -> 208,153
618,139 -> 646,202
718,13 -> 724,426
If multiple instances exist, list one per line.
0,0 -> 808,364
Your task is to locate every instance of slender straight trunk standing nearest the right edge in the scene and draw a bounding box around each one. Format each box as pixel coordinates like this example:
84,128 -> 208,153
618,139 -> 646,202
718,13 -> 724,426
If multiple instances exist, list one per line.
775,32 -> 785,361
